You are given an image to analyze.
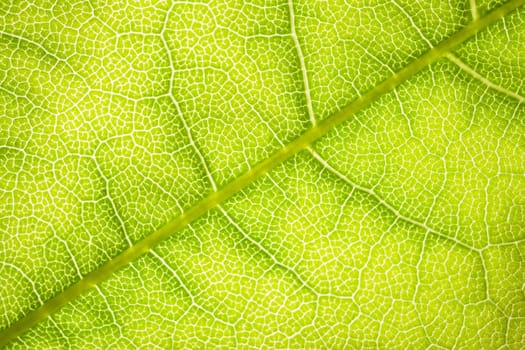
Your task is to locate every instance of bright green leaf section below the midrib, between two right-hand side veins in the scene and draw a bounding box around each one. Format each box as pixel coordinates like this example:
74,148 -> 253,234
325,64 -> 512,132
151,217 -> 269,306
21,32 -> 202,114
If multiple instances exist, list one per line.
315,60 -> 525,248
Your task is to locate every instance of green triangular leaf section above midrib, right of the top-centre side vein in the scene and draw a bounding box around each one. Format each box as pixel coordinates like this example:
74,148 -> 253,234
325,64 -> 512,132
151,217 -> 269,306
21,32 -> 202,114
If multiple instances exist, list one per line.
296,1 -> 467,119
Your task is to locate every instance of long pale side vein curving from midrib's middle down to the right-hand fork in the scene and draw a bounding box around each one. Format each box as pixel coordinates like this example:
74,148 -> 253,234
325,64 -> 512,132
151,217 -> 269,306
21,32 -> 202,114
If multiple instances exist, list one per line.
308,147 -> 481,253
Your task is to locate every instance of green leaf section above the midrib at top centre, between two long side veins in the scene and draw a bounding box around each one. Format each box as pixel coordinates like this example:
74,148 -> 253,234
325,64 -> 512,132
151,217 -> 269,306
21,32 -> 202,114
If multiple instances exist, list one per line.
164,1 -> 308,186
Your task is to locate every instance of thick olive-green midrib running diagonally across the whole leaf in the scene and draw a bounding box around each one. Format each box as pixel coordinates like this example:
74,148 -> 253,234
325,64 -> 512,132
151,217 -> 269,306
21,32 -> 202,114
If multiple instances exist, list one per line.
0,0 -> 525,347
